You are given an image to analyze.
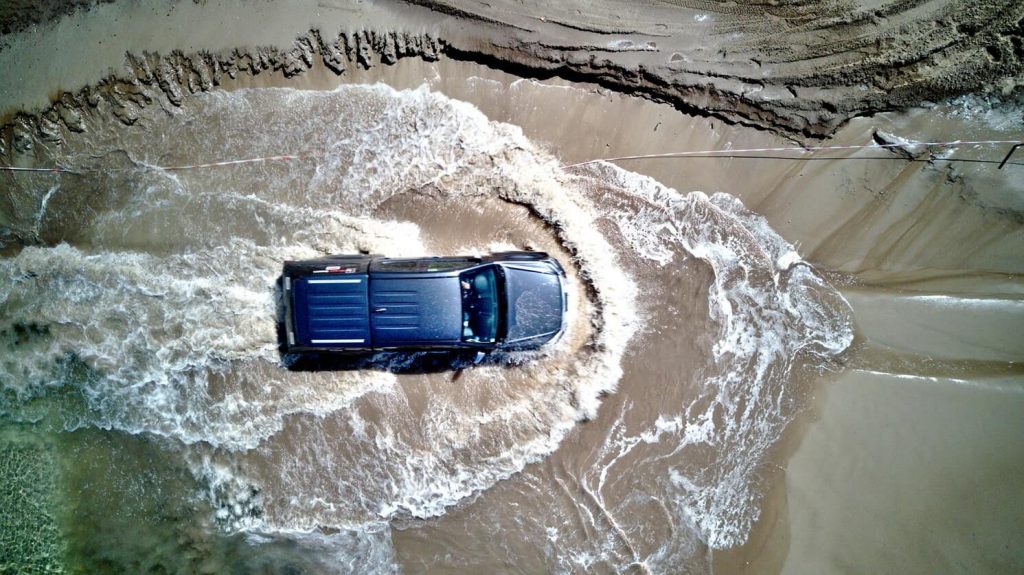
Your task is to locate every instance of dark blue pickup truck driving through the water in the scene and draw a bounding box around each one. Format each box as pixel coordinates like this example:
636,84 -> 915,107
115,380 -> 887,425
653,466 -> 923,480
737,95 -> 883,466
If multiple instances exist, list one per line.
283,252 -> 568,353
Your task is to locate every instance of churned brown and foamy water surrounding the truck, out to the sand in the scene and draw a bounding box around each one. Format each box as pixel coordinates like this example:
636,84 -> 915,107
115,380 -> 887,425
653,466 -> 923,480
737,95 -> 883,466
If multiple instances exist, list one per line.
0,85 -> 853,573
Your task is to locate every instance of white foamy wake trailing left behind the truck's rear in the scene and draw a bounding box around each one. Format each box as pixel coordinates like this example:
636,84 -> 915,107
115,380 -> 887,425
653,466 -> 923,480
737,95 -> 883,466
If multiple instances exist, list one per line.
0,239 -> 393,449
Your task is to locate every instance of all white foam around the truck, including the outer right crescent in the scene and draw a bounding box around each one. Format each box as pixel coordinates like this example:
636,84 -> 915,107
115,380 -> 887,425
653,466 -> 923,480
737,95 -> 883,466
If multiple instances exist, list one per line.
0,86 -> 849,565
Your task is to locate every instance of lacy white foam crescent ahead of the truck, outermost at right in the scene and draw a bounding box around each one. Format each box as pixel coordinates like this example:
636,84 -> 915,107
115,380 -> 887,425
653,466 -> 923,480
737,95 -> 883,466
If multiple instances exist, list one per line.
581,159 -> 853,548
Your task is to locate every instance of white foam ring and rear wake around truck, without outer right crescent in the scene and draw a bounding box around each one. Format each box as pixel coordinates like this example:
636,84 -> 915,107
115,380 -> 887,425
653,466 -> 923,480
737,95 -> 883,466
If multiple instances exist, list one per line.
4,86 -> 635,530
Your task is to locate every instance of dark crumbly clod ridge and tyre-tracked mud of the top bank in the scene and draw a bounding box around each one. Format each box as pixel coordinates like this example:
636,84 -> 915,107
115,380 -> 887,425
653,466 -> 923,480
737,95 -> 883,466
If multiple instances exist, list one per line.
0,0 -> 1024,151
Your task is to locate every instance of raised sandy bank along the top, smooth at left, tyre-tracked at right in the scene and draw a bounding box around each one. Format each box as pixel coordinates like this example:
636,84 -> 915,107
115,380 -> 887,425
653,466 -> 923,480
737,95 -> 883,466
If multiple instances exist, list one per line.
8,0 -> 1024,136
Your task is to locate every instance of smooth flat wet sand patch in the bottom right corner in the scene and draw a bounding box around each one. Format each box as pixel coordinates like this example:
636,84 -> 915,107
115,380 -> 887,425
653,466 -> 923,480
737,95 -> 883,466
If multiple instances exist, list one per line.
782,370 -> 1024,573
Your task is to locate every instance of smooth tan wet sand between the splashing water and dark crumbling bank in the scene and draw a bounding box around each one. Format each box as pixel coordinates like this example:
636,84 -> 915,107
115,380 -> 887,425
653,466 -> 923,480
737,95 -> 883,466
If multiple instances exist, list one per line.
2,2 -> 1024,573
